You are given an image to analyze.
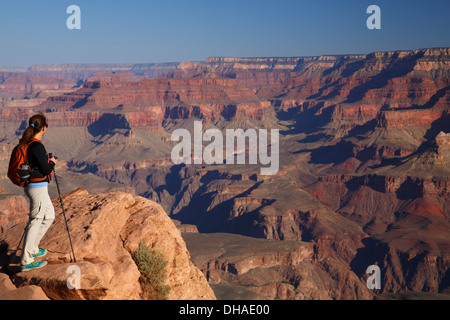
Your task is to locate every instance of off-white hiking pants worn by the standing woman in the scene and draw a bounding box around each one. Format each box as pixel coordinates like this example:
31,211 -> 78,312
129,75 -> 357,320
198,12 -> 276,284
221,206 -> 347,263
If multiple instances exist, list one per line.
20,186 -> 55,266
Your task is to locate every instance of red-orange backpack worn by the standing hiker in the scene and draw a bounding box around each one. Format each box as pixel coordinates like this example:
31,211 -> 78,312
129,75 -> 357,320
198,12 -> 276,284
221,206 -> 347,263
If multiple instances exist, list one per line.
8,139 -> 45,187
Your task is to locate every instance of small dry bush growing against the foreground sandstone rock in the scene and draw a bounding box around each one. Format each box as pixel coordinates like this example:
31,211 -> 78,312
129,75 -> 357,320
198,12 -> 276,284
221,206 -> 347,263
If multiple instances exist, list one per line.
132,242 -> 170,300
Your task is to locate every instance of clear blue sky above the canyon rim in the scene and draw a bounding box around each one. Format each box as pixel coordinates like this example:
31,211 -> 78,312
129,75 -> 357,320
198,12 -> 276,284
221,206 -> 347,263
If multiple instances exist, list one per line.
0,0 -> 450,66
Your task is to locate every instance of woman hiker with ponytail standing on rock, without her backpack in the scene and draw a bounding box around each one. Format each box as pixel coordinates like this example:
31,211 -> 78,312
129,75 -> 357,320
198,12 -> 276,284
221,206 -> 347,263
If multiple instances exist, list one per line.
19,113 -> 57,271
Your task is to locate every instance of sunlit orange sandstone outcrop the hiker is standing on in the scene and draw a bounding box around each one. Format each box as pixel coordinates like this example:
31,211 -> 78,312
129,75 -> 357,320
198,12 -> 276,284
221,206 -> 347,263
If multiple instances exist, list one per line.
0,189 -> 215,299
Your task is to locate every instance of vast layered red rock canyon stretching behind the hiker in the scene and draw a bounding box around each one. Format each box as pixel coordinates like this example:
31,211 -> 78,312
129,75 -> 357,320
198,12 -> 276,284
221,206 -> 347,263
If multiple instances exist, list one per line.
0,48 -> 450,299
